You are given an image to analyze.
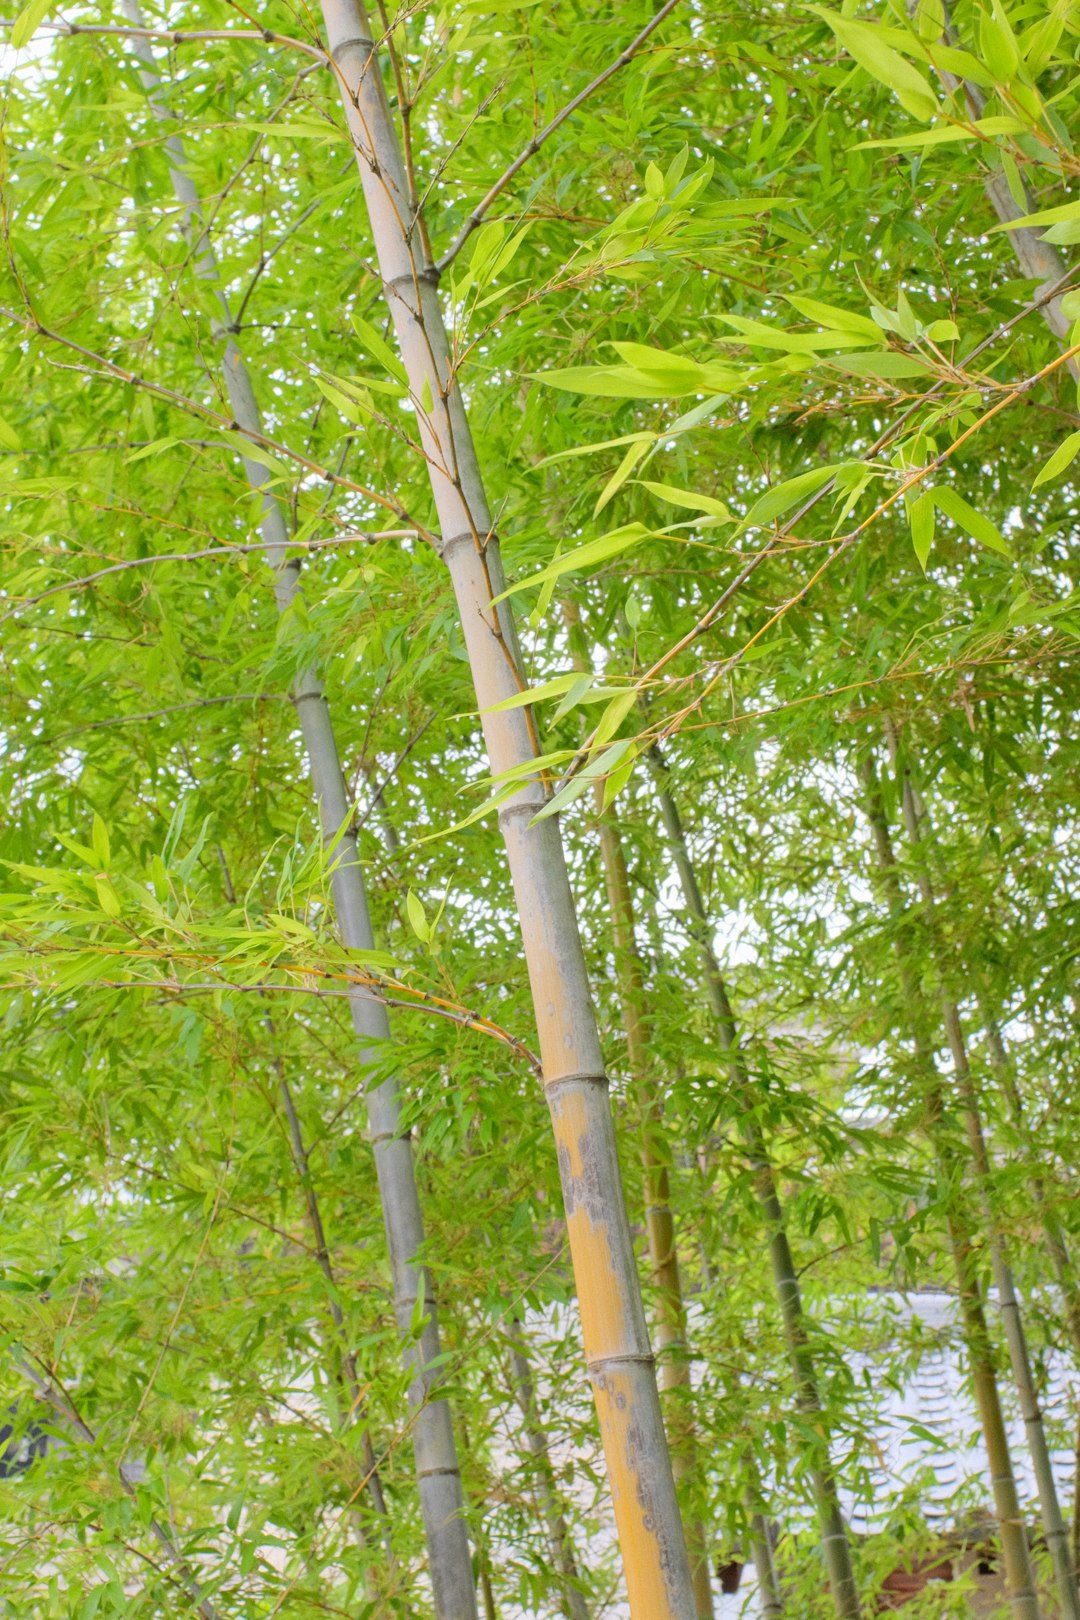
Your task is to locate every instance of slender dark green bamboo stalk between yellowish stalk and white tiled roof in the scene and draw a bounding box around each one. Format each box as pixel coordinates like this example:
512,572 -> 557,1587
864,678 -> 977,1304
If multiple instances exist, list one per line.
646,748 -> 860,1620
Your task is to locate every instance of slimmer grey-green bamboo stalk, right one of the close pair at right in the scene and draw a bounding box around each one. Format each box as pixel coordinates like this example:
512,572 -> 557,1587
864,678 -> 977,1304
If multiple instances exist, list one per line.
891,761 -> 1080,1620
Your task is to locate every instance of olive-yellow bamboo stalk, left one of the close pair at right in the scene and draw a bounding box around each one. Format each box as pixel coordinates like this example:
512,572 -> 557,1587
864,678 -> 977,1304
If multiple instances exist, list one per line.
860,758 -> 1040,1620
